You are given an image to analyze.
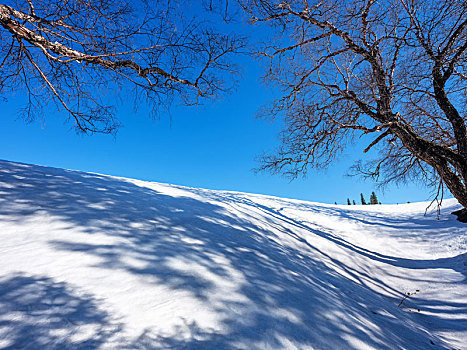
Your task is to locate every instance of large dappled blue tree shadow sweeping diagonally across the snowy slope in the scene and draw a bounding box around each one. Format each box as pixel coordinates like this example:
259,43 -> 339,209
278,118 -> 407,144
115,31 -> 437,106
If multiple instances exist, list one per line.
0,161 -> 467,349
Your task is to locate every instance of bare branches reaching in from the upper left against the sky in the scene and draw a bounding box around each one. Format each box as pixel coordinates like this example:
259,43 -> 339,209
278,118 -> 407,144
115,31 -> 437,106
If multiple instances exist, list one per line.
0,0 -> 244,133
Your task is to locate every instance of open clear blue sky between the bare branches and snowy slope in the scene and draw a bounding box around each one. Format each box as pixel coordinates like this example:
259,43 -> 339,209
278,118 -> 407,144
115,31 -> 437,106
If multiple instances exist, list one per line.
0,53 -> 436,204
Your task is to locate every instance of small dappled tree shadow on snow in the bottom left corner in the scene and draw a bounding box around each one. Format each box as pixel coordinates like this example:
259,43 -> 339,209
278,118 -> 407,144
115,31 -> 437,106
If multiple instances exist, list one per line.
0,274 -> 119,349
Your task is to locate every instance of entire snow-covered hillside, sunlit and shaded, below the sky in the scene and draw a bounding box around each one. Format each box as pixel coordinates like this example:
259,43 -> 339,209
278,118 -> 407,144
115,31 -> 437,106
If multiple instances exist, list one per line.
0,161 -> 467,349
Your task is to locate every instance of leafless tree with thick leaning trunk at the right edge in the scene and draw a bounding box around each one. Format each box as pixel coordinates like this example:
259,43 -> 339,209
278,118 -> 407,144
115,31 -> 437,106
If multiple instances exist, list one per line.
241,0 -> 467,220
